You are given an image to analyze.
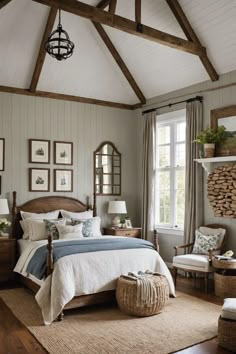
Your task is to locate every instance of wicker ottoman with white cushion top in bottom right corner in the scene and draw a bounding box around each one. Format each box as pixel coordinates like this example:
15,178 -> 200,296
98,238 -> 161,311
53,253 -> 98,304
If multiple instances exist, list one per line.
218,298 -> 236,353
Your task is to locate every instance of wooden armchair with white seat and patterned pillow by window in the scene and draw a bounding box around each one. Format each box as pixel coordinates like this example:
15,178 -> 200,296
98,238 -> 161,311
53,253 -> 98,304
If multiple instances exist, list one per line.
173,224 -> 226,291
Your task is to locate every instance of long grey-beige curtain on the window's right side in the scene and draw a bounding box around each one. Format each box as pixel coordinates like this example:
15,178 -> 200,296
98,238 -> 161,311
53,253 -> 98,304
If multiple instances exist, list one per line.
184,100 -> 203,243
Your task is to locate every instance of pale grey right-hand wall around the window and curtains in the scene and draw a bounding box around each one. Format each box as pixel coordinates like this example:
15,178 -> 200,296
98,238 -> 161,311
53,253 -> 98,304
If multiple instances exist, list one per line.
137,71 -> 236,262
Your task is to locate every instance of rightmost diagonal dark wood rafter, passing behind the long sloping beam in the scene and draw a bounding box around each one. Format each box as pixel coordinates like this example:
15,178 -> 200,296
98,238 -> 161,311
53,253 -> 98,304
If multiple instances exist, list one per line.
166,0 -> 219,81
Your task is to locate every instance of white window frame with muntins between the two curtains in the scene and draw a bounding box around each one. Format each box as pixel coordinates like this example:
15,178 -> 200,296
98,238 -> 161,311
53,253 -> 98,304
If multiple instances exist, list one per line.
155,109 -> 186,231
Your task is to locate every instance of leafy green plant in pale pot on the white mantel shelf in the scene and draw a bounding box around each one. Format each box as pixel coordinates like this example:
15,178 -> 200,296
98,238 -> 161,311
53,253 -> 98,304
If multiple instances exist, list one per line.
195,125 -> 227,158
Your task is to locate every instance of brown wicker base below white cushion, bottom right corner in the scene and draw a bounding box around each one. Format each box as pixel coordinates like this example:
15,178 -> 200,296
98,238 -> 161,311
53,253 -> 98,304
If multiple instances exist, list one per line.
218,317 -> 236,353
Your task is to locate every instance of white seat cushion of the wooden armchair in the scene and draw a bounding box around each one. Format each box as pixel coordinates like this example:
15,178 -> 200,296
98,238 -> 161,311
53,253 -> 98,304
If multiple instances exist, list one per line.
173,254 -> 213,272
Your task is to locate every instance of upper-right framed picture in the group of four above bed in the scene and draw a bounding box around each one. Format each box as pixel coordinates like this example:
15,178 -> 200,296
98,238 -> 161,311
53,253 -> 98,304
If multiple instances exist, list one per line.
54,141 -> 73,165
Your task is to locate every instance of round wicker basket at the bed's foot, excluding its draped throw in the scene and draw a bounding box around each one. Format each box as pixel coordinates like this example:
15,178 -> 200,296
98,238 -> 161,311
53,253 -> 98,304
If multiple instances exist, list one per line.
116,275 -> 169,316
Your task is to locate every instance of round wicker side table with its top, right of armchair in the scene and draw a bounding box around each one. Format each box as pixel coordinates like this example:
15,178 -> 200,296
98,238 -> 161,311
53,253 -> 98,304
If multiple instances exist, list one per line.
212,257 -> 236,298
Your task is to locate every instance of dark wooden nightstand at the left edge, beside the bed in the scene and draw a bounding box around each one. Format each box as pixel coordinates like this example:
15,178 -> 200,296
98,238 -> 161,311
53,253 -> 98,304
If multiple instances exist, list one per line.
0,237 -> 16,281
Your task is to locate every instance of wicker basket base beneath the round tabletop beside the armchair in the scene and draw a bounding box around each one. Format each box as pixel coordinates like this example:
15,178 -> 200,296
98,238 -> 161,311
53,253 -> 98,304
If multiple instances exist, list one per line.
214,272 -> 236,298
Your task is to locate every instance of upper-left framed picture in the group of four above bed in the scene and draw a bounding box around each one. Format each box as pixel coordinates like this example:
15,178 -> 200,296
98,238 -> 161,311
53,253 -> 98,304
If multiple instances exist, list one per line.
29,139 -> 50,164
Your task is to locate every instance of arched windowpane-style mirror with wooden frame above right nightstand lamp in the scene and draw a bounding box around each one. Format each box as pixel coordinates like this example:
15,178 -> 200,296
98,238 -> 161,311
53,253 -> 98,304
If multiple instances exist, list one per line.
94,141 -> 121,195
